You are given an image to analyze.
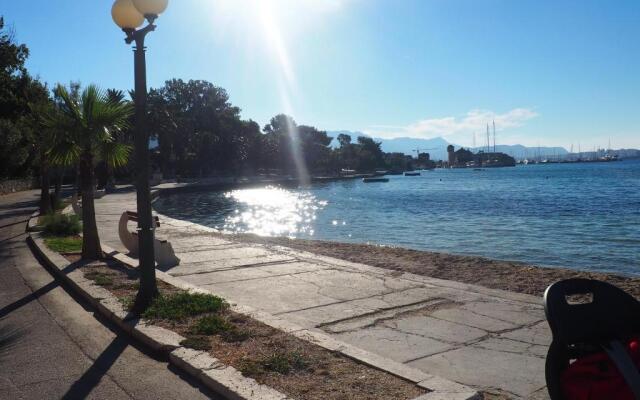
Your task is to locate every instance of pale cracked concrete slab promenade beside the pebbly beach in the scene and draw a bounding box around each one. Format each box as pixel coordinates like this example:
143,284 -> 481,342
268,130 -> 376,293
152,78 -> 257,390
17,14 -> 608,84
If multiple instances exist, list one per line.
97,193 -> 550,399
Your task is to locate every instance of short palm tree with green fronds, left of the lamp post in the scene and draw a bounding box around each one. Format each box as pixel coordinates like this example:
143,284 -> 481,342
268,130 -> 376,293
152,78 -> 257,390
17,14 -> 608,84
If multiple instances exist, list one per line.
48,85 -> 133,259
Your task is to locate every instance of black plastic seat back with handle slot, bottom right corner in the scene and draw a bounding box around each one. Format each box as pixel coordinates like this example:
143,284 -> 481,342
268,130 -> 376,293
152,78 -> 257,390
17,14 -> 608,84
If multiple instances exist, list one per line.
544,278 -> 640,400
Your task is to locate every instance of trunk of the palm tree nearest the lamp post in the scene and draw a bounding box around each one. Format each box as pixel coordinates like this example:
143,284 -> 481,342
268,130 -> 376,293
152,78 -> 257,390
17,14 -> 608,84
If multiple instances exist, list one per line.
80,149 -> 103,260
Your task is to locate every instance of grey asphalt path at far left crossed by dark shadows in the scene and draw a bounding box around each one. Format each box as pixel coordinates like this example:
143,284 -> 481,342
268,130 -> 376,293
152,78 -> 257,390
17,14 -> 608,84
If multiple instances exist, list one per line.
0,191 -> 218,400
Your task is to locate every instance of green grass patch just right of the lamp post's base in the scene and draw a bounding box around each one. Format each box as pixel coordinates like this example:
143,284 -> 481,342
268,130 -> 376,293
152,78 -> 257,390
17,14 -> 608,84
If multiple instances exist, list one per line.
142,292 -> 228,321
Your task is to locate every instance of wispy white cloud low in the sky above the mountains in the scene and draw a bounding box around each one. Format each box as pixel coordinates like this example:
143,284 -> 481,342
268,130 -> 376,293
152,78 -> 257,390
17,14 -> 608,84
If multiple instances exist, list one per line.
367,108 -> 538,139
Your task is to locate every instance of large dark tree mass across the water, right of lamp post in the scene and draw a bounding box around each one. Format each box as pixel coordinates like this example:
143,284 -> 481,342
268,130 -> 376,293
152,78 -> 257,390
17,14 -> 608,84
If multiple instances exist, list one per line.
149,79 -> 387,177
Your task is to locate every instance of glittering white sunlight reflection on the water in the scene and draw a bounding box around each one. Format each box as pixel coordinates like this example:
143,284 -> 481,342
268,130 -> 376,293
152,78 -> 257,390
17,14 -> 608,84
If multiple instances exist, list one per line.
221,186 -> 327,237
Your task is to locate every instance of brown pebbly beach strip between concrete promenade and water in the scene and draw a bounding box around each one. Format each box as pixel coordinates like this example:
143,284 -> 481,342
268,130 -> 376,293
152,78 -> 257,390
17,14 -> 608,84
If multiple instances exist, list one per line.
218,233 -> 640,300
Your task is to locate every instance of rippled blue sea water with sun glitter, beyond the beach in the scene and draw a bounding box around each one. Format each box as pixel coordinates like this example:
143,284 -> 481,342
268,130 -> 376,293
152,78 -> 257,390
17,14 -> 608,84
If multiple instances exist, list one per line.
154,160 -> 640,275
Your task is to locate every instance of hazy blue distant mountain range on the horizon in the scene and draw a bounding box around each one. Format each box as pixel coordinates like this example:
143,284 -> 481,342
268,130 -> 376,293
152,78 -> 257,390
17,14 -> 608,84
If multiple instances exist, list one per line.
327,131 -> 569,160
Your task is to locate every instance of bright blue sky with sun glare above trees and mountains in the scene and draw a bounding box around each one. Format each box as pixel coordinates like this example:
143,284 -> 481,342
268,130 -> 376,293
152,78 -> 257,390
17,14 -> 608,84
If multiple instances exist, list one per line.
5,0 -> 640,150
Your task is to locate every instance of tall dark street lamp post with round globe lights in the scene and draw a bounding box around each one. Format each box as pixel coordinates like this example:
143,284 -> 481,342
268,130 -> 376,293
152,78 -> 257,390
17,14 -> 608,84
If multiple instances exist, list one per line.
111,0 -> 168,311
